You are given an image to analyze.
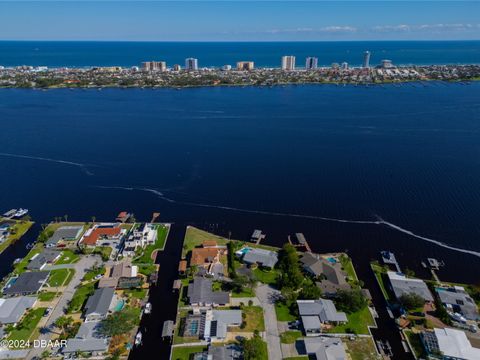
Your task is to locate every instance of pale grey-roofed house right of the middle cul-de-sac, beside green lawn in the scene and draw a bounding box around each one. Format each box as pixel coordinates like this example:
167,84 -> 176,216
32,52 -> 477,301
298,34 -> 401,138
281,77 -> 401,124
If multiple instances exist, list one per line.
297,299 -> 348,336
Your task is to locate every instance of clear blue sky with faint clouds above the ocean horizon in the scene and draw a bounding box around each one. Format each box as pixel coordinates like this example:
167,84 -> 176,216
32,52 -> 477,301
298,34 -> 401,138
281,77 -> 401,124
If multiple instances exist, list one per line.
0,0 -> 480,41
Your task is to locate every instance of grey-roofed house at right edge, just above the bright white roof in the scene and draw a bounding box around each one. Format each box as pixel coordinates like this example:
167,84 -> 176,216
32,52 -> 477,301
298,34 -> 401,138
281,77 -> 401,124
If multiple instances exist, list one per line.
435,286 -> 480,321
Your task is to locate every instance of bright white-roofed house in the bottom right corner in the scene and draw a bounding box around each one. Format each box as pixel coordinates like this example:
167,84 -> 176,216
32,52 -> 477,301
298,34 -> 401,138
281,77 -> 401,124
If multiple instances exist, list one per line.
420,328 -> 480,360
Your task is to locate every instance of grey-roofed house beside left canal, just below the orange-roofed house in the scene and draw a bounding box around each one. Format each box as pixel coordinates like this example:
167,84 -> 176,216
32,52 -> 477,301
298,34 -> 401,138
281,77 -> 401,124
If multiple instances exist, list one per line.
187,277 -> 230,307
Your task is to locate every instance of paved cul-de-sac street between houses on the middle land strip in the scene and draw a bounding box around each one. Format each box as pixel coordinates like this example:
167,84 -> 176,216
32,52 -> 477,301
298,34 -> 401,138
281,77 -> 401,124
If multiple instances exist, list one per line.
256,285 -> 283,360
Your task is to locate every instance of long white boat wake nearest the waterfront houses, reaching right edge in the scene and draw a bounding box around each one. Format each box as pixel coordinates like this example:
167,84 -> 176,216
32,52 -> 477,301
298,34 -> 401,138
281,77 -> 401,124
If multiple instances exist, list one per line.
96,186 -> 480,258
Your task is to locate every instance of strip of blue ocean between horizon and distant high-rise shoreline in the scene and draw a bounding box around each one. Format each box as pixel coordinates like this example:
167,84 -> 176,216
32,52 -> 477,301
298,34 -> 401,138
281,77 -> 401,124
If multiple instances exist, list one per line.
0,41 -> 480,67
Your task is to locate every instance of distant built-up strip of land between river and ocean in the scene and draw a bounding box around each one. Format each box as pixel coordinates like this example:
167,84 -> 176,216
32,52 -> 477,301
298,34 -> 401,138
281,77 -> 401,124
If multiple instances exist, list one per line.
0,62 -> 480,89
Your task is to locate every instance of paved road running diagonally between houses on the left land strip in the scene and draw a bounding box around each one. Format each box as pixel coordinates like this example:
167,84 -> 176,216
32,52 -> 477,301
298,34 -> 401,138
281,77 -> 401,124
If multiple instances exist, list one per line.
26,255 -> 102,360
